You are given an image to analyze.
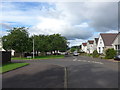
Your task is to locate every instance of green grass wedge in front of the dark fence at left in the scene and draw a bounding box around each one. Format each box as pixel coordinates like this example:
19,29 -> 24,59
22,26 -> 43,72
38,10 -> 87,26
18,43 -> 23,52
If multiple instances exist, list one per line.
0,63 -> 29,73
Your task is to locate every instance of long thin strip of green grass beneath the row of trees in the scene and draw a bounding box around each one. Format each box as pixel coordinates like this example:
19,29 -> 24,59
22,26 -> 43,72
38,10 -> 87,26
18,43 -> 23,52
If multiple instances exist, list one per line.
12,55 -> 64,60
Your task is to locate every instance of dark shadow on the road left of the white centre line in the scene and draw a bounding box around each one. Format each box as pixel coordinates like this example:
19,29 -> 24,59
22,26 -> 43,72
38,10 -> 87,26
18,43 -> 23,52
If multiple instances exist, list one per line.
2,67 -> 64,88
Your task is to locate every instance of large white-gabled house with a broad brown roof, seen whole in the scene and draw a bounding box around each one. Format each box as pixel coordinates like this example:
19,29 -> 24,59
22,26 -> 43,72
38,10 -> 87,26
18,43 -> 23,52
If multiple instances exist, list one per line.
97,33 -> 117,54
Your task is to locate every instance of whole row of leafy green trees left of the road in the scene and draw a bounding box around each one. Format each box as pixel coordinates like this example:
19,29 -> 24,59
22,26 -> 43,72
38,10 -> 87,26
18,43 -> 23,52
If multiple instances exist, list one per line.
2,27 -> 68,55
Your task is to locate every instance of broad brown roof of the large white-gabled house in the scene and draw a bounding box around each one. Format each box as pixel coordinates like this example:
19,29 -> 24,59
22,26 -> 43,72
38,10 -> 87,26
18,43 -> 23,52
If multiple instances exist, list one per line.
100,33 -> 118,46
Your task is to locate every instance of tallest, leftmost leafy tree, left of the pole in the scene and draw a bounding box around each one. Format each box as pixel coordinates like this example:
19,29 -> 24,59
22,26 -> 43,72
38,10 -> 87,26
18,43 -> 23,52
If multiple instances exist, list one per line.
3,27 -> 30,55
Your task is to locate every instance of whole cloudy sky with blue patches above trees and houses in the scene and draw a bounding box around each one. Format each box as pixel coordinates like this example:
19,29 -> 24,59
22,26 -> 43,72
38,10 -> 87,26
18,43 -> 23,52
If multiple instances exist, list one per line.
0,2 -> 118,46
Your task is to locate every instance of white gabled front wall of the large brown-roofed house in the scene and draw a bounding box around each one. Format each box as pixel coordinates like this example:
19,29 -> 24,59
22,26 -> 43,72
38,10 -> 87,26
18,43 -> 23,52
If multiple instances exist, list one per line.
97,36 -> 104,54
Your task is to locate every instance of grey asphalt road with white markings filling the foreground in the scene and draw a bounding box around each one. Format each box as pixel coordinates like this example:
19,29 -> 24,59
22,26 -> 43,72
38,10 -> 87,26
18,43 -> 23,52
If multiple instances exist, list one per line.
3,56 -> 118,88
